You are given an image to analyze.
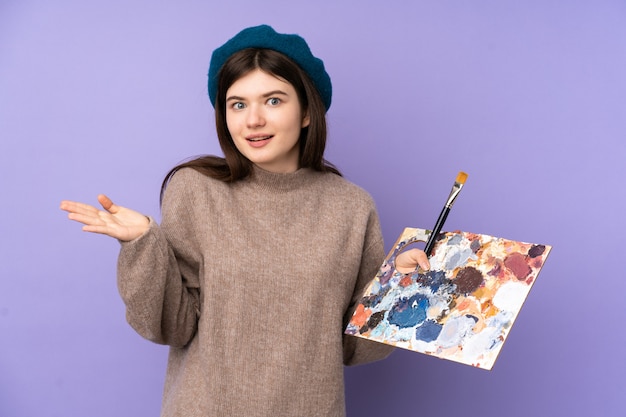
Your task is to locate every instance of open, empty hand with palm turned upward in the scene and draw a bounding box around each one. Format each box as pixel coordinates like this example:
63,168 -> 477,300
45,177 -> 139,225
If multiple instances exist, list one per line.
61,194 -> 150,241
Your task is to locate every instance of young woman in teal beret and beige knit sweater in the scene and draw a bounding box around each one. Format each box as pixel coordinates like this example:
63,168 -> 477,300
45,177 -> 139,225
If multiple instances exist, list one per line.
61,26 -> 428,417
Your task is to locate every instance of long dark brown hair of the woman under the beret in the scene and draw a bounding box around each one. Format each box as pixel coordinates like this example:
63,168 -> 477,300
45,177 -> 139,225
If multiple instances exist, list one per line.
161,48 -> 341,201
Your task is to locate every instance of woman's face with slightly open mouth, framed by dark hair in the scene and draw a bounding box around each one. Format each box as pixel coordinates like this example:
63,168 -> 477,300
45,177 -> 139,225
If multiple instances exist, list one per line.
226,69 -> 309,173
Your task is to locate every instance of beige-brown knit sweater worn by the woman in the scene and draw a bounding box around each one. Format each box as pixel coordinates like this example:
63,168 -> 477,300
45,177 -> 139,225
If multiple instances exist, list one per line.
118,169 -> 392,417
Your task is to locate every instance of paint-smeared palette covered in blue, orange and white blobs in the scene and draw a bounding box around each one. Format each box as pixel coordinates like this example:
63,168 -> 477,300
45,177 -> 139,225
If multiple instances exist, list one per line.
346,228 -> 551,369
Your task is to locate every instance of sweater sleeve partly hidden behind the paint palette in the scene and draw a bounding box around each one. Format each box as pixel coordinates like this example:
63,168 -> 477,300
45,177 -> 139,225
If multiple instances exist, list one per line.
343,202 -> 394,366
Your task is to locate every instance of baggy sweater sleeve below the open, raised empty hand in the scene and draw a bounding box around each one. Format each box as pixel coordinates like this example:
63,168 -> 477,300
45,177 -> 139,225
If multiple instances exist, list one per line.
118,173 -> 200,347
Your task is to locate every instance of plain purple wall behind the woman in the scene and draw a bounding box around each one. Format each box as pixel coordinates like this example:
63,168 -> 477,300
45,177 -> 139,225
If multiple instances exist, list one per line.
0,0 -> 626,417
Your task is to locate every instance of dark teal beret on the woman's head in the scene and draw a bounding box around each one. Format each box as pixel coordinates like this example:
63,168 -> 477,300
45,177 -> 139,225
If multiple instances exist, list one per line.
208,25 -> 332,110
